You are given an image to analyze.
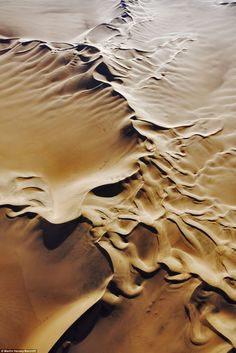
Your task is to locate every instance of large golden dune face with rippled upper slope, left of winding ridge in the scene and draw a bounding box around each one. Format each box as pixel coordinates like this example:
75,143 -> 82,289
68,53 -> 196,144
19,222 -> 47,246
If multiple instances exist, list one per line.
0,41 -> 143,223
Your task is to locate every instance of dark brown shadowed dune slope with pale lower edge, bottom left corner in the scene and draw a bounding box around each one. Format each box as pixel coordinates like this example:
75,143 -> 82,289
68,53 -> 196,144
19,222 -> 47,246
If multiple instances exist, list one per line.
0,208 -> 111,352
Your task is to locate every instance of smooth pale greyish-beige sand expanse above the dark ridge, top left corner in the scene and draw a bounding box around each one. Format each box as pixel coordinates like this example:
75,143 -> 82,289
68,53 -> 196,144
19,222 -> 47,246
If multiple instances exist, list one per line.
0,0 -> 119,41
